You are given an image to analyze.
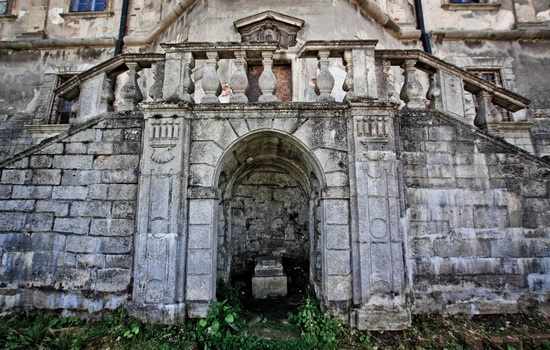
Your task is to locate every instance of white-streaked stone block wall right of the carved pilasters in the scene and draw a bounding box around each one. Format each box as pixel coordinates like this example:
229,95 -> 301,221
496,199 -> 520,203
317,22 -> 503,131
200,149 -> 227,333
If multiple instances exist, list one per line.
400,111 -> 550,314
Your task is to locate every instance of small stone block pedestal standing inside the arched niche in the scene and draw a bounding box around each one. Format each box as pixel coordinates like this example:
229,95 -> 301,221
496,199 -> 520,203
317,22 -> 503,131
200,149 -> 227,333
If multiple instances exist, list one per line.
252,257 -> 288,299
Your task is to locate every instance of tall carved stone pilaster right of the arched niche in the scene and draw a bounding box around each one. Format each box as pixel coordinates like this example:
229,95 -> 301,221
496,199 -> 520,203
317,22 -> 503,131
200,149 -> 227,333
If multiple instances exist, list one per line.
350,104 -> 410,330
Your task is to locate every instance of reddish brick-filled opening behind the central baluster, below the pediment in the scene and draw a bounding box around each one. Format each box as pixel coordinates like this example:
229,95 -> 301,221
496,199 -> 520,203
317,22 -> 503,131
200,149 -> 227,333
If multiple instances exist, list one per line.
248,64 -> 292,102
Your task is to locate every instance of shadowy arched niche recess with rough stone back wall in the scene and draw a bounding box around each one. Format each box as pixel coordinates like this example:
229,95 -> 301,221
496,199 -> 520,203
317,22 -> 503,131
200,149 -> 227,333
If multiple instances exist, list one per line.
217,131 -> 322,296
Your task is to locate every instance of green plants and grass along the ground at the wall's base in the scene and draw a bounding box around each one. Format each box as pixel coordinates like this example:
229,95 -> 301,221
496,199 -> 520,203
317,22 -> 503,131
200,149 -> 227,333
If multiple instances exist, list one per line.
0,294 -> 550,350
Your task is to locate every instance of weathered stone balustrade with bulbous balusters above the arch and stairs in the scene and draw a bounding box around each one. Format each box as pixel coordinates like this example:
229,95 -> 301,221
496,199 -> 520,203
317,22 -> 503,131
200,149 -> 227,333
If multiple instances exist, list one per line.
55,40 -> 529,136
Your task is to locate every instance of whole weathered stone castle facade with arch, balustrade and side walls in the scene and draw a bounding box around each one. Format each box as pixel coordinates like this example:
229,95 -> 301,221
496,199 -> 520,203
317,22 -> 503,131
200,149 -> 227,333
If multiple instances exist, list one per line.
0,0 -> 550,330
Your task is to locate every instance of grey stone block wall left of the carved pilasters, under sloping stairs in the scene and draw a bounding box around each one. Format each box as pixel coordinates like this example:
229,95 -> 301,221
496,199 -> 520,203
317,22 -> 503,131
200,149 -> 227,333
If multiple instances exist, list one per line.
0,114 -> 142,311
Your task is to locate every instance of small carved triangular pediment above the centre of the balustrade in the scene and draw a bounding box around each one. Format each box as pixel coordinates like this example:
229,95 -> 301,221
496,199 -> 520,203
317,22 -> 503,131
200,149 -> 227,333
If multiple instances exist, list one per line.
233,11 -> 304,49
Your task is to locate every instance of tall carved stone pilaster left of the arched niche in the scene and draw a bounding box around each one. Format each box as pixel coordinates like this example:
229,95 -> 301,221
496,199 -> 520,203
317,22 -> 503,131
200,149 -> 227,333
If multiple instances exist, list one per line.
129,107 -> 189,323
